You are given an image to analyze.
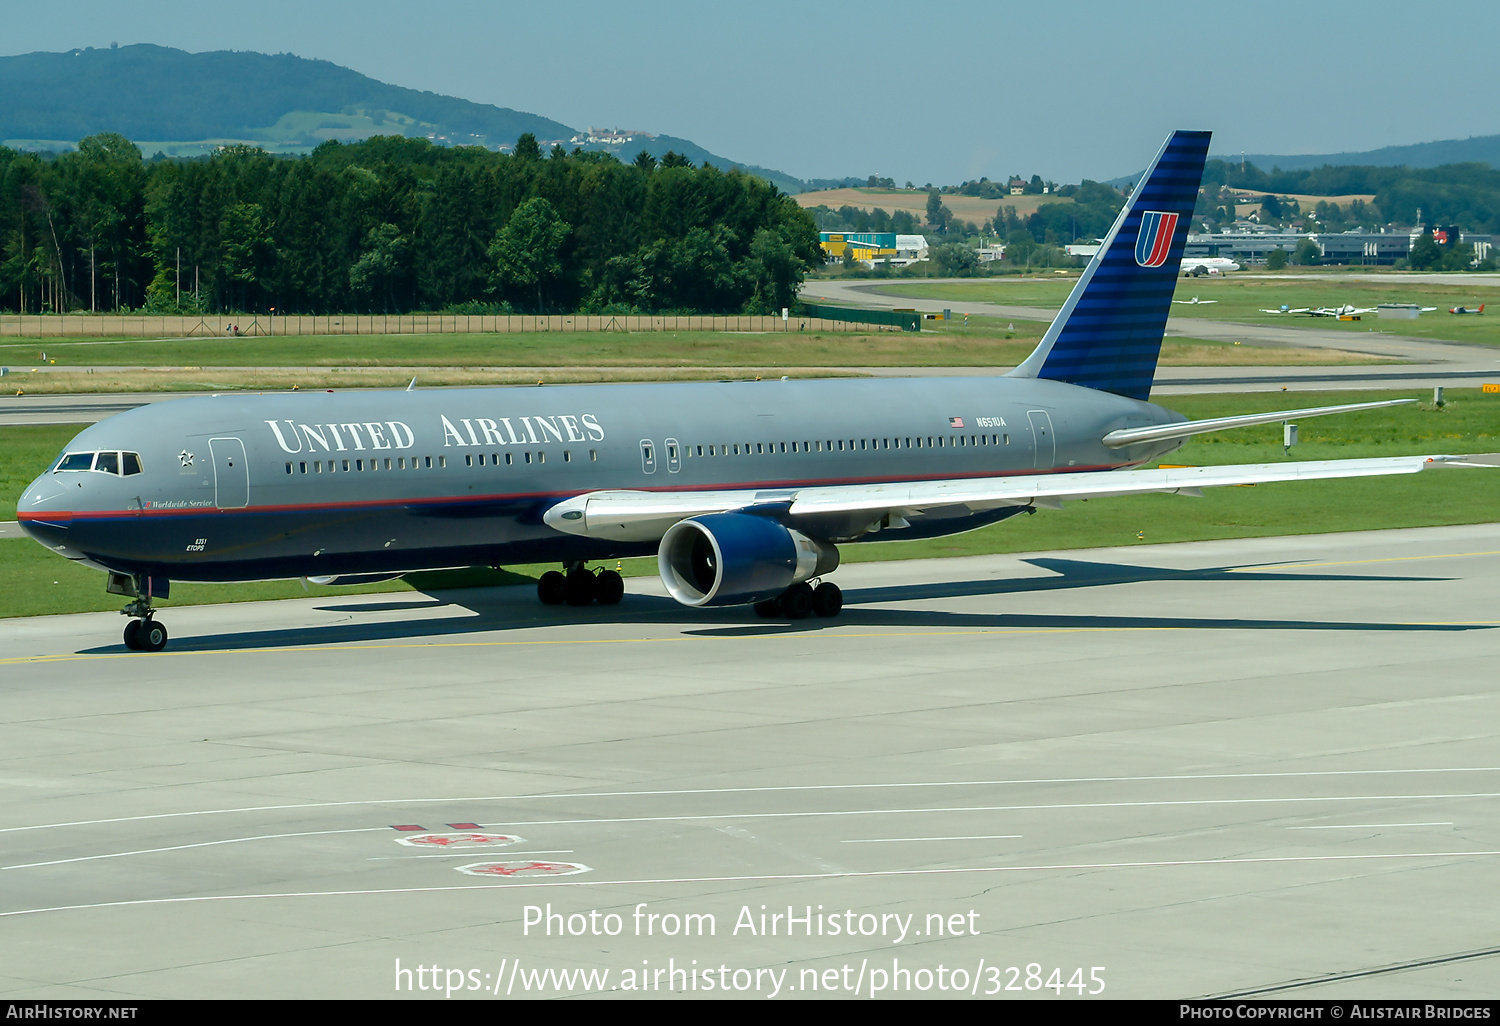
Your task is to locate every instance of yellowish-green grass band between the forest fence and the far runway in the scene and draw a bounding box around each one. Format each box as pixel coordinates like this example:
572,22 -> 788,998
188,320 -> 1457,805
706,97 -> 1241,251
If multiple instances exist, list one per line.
0,318 -> 1370,402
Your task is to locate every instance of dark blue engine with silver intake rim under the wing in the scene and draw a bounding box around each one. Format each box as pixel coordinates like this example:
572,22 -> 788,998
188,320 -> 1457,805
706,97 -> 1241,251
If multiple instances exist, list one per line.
657,513 -> 839,606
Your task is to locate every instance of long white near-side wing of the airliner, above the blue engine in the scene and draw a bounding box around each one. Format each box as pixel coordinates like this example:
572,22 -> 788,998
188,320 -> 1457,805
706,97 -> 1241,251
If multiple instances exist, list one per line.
545,455 -> 1500,542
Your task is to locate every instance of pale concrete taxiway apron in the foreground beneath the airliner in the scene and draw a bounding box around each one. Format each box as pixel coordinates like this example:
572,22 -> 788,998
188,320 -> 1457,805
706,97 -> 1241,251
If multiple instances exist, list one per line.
0,525 -> 1500,1001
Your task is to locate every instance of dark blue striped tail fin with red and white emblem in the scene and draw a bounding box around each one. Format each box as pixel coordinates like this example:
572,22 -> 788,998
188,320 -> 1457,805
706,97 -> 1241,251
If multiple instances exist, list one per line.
1011,132 -> 1211,399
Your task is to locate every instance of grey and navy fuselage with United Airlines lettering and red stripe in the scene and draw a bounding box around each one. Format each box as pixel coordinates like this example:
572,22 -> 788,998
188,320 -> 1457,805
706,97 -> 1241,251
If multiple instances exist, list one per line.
18,377 -> 1182,581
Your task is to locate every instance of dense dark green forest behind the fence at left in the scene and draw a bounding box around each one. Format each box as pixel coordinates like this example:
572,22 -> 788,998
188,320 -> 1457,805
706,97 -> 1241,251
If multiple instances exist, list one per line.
0,134 -> 822,314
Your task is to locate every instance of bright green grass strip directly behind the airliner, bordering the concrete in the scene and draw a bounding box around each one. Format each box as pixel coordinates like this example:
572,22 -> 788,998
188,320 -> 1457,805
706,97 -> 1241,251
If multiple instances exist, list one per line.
0,389 -> 1500,617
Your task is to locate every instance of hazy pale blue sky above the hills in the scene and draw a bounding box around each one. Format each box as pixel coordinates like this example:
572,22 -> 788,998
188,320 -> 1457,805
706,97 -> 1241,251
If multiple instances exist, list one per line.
0,0 -> 1500,185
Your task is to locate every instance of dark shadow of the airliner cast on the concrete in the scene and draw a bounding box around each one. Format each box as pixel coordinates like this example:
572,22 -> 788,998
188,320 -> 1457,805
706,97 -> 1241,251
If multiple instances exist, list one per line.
83,558 -> 1493,653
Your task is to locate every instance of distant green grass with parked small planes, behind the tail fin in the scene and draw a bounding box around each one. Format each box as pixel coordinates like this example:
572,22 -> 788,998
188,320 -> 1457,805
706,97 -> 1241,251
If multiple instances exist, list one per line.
876,276 -> 1500,345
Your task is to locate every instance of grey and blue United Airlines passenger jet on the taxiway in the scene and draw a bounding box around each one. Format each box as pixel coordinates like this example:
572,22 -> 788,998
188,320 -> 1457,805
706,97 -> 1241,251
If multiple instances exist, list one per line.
18,132 -> 1488,651
